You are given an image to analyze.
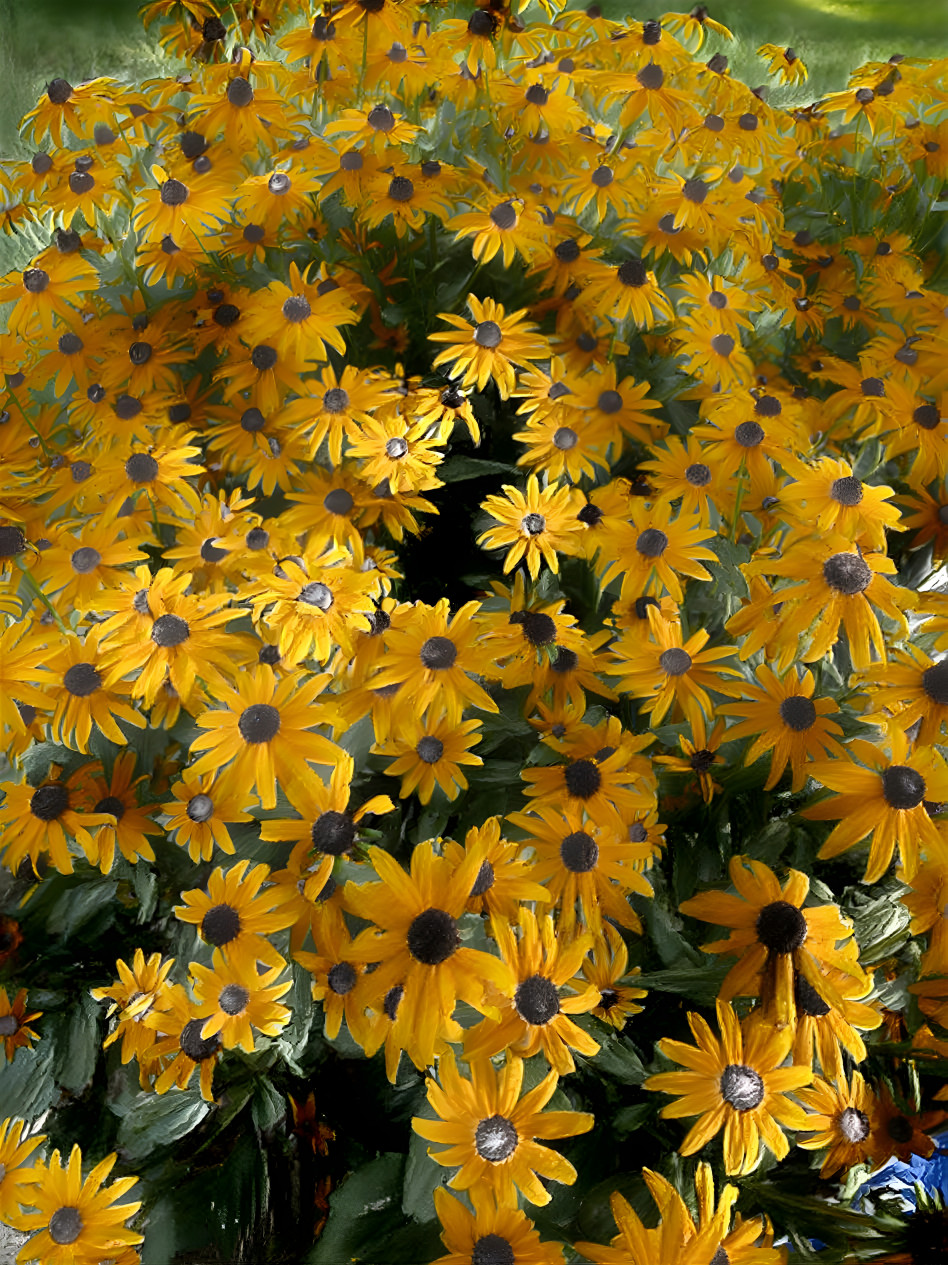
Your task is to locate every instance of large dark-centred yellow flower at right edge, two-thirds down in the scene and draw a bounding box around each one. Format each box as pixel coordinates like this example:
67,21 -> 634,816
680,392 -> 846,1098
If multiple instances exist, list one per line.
802,727 -> 948,883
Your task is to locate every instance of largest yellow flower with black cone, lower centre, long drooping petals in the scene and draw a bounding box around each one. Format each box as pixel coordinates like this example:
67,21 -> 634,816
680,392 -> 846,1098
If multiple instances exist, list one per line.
346,842 -> 513,1068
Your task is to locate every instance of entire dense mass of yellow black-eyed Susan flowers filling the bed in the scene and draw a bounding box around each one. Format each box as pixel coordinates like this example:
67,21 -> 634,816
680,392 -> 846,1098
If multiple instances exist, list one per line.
0,0 -> 948,1265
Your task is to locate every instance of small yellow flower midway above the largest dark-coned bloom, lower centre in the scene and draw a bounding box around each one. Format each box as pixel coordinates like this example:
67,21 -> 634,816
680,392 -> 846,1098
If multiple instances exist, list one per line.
373,716 -> 483,803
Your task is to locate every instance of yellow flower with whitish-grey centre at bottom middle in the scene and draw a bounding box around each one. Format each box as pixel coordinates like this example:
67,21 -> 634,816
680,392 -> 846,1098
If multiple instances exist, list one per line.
411,1051 -> 594,1207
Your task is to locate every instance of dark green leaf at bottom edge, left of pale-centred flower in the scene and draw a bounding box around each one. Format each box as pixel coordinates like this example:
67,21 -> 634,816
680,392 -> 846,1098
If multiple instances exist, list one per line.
306,1151 -> 405,1265
